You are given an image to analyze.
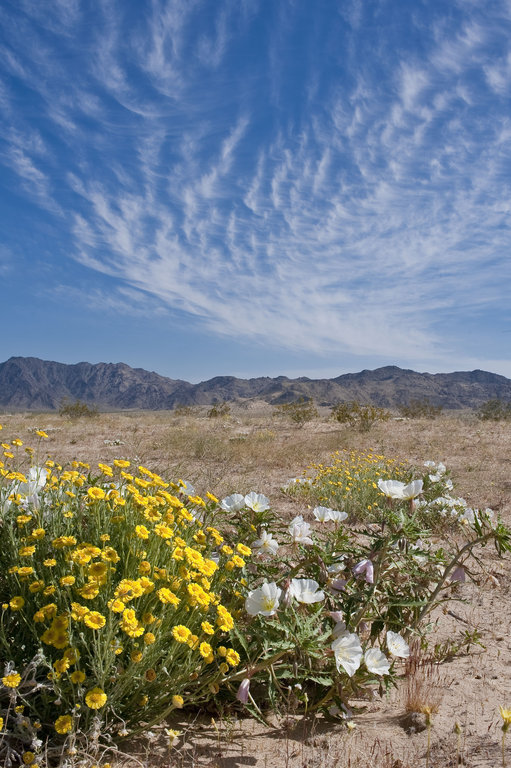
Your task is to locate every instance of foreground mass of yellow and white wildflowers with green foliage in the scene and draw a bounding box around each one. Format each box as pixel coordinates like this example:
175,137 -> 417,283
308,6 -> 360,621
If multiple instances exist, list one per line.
0,424 -> 510,764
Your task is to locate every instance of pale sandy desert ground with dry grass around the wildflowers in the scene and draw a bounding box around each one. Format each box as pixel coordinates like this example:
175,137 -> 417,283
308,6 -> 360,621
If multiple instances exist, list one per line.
0,404 -> 511,768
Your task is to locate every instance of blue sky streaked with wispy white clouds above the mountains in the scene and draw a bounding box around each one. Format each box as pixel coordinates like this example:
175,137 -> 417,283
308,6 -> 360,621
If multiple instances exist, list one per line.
0,0 -> 511,381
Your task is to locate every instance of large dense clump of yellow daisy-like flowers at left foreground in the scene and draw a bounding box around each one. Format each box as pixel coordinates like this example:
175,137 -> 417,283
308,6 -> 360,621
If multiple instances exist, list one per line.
0,448 -> 251,736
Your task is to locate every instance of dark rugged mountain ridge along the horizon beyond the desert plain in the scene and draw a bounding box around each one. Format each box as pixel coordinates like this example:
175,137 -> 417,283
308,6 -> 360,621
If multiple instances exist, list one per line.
0,357 -> 511,411
